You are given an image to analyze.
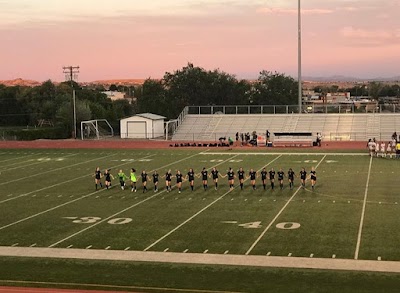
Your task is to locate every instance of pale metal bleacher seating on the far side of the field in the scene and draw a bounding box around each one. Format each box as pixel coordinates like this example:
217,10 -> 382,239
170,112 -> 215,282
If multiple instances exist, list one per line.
172,113 -> 400,141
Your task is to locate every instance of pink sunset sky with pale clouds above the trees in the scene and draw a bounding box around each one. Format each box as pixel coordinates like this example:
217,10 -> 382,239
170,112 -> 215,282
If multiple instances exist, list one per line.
0,0 -> 400,81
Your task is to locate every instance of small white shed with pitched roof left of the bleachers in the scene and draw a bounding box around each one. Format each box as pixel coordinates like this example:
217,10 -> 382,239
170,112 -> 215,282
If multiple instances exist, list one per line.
120,113 -> 165,139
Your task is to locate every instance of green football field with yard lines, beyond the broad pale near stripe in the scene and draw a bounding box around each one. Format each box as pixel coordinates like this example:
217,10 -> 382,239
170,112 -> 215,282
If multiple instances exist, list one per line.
0,148 -> 400,292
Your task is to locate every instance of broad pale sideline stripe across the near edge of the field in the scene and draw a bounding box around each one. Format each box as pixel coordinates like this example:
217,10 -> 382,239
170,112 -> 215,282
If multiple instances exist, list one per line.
0,246 -> 400,273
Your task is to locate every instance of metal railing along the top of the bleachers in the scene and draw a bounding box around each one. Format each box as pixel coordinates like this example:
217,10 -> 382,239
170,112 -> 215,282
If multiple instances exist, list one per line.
186,104 -> 400,114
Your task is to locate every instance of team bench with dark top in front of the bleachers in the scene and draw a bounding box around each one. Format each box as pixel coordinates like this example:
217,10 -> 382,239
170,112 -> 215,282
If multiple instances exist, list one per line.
273,132 -> 315,147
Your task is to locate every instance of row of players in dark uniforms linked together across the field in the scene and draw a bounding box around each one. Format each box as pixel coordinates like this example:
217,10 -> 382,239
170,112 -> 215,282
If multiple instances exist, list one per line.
94,167 -> 317,193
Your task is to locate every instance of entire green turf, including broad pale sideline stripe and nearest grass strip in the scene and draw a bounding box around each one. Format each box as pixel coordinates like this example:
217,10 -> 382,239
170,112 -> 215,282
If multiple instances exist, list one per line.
0,148 -> 400,293
